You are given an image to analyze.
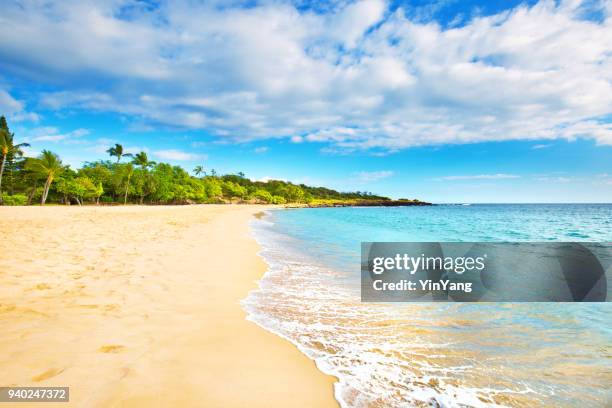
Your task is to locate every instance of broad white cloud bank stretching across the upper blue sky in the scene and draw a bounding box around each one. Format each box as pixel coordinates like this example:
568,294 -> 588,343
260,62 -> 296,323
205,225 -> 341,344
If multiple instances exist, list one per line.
0,0 -> 612,151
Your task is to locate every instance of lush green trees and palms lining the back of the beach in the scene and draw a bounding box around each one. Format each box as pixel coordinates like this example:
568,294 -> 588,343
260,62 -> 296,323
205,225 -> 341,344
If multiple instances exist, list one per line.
0,116 -> 396,205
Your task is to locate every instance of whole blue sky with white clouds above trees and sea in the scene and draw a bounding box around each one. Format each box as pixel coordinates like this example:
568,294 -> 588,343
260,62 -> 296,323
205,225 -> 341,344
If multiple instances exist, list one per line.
0,0 -> 612,203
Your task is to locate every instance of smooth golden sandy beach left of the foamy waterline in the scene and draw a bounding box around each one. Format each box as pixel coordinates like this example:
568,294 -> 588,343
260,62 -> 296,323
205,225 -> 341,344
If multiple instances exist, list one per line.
0,205 -> 337,407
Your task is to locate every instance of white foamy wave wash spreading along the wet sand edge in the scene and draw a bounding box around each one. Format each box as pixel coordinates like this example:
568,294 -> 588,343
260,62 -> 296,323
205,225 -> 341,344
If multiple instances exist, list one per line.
242,214 -> 530,407
